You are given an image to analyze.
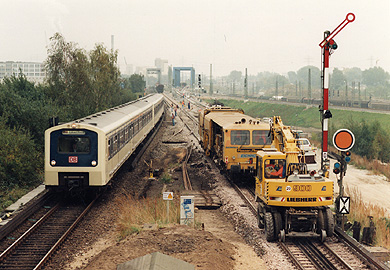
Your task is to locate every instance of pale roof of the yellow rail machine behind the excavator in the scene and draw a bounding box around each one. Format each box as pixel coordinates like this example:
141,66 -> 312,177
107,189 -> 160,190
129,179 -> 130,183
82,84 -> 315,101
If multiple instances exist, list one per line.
205,111 -> 269,129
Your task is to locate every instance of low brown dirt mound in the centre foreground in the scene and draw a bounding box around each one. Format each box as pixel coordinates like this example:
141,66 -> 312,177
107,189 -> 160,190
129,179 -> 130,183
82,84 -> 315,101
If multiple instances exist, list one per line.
83,225 -> 235,270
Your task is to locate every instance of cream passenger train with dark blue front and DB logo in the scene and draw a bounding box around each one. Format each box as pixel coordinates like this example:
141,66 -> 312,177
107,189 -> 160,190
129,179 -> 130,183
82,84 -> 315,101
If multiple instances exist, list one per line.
45,94 -> 164,191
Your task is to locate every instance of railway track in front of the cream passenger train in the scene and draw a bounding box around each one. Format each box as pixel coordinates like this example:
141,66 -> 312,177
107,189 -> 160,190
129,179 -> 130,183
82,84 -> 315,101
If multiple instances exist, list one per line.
0,196 -> 96,269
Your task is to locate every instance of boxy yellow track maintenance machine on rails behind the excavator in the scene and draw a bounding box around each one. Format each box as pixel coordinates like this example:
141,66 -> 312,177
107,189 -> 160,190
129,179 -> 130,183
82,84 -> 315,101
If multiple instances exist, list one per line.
199,106 -> 271,173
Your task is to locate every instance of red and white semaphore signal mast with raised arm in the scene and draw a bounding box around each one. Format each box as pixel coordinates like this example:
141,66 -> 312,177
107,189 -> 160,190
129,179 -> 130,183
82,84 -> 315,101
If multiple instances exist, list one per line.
319,13 -> 355,176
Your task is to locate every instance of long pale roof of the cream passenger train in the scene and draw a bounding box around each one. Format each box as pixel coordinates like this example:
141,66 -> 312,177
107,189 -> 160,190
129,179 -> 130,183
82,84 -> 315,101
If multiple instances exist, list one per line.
46,94 -> 163,133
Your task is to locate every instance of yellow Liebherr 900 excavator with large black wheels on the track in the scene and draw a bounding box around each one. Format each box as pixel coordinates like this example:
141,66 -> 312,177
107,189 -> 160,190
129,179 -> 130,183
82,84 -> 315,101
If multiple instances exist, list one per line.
255,116 -> 334,241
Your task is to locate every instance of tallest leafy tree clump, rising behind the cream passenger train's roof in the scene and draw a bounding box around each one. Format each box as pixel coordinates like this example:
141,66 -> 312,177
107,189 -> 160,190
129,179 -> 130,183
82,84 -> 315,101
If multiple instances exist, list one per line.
45,33 -> 123,119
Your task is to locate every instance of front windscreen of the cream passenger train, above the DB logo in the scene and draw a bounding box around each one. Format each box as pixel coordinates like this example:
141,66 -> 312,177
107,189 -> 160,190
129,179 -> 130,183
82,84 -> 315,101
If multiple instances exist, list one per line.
58,136 -> 91,154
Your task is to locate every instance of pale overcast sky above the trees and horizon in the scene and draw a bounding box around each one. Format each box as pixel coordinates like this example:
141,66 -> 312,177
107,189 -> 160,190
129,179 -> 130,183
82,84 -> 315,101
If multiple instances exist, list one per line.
0,0 -> 390,75
